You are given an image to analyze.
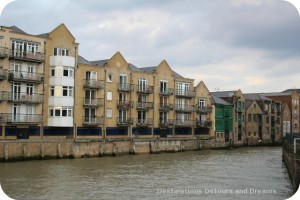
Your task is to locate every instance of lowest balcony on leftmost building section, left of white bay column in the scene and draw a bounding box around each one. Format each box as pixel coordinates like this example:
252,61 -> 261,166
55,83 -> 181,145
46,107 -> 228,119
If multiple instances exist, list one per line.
4,113 -> 43,124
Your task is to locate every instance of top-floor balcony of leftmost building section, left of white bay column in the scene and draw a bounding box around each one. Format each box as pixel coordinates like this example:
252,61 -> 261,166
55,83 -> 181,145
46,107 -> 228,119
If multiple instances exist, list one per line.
9,50 -> 45,63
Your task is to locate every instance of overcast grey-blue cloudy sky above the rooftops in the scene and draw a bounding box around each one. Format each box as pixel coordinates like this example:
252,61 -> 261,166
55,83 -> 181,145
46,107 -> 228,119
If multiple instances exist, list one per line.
0,0 -> 300,93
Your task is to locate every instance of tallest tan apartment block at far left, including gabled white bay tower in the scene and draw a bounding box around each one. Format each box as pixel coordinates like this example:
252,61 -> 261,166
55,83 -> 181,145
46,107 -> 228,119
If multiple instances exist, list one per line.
0,24 -> 78,139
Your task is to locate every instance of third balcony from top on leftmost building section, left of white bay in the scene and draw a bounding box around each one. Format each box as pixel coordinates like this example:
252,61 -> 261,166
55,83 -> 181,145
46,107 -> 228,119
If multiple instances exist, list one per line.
7,92 -> 44,104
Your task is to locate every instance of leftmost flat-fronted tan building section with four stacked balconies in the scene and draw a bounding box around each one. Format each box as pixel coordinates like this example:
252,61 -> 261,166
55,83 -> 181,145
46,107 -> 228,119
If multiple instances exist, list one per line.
0,26 -> 45,139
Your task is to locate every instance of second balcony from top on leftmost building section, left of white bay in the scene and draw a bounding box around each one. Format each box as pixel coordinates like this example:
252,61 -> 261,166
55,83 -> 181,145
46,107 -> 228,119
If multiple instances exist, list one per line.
8,70 -> 44,83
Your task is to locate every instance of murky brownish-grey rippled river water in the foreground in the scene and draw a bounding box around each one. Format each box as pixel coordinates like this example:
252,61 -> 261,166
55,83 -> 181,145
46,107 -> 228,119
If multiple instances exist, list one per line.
0,147 -> 292,200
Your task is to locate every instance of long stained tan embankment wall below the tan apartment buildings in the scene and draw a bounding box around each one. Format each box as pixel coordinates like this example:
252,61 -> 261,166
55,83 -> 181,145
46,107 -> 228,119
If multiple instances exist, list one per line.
0,139 -> 226,161
